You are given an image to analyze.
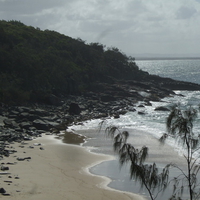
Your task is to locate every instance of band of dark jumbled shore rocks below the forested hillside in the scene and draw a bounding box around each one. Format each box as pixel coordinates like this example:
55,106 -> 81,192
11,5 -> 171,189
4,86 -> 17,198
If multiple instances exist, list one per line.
0,73 -> 200,157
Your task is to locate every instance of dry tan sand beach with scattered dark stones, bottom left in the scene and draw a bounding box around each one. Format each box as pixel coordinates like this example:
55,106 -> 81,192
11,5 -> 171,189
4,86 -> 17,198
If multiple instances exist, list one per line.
0,135 -> 144,200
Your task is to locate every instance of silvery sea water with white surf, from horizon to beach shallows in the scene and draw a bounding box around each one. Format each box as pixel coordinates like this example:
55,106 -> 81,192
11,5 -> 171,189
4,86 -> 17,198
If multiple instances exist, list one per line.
68,60 -> 200,200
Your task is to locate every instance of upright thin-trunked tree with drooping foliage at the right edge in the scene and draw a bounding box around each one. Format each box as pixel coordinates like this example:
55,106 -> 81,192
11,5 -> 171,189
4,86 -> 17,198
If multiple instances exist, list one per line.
160,105 -> 200,200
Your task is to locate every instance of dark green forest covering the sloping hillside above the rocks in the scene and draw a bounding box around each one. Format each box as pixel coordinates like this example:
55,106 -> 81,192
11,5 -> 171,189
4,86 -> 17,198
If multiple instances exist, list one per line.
0,20 -> 147,103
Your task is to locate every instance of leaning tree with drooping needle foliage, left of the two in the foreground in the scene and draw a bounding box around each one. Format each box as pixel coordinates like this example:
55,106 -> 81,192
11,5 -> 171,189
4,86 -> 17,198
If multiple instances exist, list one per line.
100,121 -> 170,200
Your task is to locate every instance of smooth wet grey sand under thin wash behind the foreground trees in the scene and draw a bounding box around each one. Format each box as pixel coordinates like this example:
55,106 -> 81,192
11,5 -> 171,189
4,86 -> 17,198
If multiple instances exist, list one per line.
72,126 -> 188,199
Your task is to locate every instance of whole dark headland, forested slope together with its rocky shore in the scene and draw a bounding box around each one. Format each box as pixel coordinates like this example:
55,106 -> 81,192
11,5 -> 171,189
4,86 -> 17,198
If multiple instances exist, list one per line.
0,21 -> 200,195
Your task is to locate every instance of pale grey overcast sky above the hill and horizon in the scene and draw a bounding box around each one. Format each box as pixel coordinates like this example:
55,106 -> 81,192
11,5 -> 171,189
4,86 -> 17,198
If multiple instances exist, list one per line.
0,0 -> 200,56
